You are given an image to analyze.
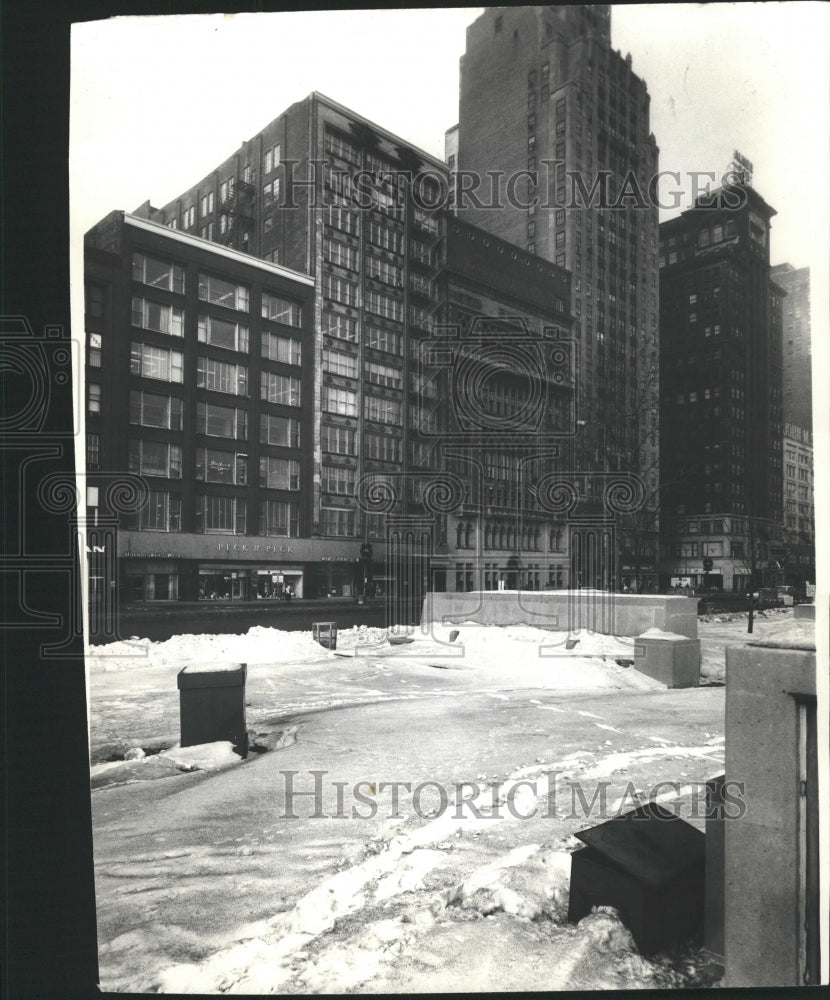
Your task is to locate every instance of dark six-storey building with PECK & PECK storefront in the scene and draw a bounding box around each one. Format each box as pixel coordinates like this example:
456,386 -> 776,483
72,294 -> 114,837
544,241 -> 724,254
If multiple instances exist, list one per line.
85,212 -> 368,601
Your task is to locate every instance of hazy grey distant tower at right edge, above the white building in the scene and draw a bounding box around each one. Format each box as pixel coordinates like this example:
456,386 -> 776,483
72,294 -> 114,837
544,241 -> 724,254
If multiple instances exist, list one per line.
772,264 -> 813,431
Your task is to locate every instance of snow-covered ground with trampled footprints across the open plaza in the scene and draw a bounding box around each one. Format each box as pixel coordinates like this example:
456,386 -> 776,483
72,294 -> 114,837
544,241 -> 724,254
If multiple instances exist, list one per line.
88,619 -> 816,993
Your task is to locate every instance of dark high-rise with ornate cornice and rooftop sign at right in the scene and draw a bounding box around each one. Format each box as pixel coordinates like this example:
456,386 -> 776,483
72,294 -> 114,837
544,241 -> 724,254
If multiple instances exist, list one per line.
660,186 -> 784,591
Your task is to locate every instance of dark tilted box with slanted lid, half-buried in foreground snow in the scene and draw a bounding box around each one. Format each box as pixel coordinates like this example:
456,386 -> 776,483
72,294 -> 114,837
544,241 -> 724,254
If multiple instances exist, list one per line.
568,802 -> 706,955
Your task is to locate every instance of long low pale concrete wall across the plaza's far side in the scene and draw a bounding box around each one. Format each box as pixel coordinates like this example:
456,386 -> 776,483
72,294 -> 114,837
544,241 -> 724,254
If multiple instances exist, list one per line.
421,590 -> 697,639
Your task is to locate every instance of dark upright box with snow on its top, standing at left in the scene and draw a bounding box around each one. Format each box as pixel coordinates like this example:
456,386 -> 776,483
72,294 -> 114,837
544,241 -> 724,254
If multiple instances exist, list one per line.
178,663 -> 248,757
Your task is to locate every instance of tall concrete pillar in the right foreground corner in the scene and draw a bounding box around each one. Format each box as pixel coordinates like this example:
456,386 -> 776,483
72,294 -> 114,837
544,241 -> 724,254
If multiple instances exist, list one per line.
724,628 -> 818,988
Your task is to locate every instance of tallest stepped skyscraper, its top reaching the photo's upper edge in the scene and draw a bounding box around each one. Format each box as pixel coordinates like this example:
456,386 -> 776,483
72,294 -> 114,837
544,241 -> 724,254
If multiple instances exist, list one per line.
452,4 -> 659,585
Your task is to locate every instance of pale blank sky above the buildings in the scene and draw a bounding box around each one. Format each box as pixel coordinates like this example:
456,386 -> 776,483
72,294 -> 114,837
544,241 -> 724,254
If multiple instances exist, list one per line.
75,2 -> 830,274
